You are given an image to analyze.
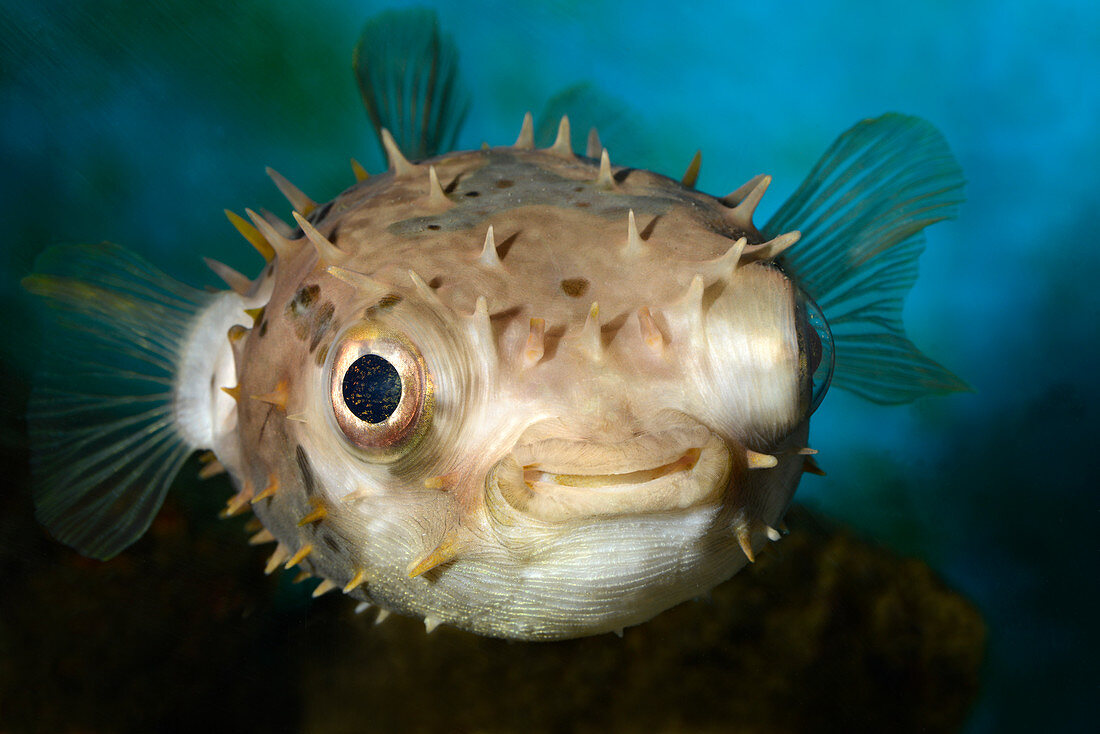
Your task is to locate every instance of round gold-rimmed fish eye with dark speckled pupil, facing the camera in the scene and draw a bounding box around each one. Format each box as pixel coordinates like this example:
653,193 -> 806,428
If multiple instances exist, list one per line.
330,325 -> 431,463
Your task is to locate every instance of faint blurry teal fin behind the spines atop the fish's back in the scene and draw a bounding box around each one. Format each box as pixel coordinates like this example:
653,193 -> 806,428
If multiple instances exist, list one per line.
535,81 -> 641,160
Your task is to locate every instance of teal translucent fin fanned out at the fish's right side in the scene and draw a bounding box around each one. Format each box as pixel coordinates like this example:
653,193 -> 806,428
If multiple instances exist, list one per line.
763,113 -> 969,404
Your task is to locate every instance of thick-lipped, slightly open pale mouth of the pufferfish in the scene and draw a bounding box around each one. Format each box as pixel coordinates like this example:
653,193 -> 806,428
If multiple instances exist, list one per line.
487,413 -> 730,523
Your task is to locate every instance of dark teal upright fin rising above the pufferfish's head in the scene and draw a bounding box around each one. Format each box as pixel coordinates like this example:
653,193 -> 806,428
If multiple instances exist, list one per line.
353,8 -> 470,161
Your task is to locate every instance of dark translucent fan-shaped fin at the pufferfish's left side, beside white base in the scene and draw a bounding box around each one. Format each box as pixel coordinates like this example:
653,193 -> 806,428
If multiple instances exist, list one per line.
23,243 -> 213,559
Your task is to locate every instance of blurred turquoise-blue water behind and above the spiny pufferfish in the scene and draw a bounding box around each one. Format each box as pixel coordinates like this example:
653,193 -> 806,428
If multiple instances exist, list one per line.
0,0 -> 1100,732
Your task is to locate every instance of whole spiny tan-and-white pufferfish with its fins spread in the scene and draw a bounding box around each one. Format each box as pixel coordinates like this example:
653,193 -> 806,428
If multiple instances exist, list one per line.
24,12 -> 964,640
